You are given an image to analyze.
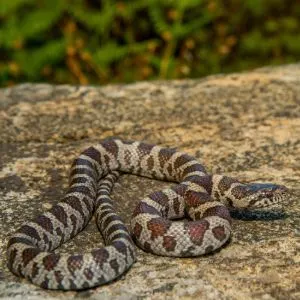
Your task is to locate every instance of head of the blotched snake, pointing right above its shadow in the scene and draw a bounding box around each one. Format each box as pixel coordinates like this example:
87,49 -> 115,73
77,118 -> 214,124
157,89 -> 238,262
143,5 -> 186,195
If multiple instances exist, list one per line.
244,183 -> 289,209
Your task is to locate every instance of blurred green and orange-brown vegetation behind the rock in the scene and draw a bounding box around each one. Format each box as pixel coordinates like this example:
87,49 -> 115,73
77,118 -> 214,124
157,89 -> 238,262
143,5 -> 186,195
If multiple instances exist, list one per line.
0,0 -> 300,86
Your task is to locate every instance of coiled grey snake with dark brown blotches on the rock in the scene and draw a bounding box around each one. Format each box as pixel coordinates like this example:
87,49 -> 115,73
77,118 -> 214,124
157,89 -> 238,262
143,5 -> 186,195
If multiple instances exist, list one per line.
7,138 -> 288,290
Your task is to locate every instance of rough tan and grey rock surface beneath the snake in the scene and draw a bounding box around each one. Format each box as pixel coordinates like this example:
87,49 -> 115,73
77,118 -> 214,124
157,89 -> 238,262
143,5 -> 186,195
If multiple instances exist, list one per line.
0,64 -> 300,300
